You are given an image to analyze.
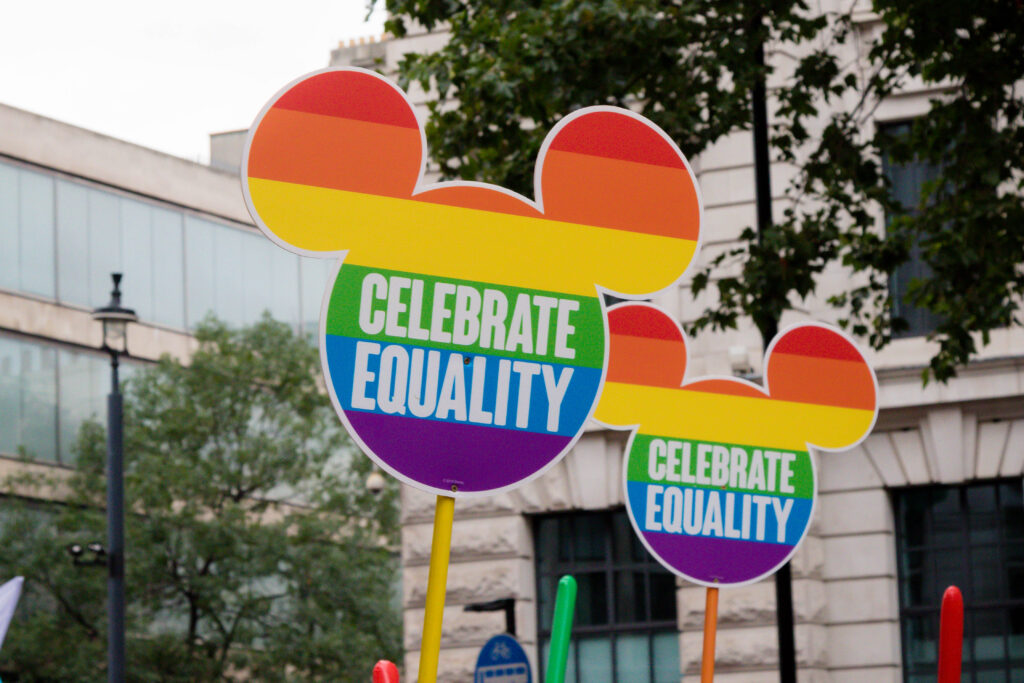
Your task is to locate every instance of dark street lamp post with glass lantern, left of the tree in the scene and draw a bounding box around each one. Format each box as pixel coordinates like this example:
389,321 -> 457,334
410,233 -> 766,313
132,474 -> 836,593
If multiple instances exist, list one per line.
92,272 -> 138,683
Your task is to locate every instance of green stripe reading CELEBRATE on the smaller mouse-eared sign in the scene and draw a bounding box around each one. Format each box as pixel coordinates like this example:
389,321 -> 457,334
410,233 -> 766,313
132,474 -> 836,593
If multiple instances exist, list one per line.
627,434 -> 814,498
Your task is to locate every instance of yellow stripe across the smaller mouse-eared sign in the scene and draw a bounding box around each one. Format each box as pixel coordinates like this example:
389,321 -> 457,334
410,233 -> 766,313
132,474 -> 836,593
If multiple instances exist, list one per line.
594,382 -> 874,451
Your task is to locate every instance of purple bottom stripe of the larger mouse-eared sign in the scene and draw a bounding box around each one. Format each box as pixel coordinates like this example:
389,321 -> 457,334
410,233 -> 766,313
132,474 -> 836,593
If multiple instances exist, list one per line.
345,411 -> 572,492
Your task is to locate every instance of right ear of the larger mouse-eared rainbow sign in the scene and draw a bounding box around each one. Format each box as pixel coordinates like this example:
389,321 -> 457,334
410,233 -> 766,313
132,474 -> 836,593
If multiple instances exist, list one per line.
537,106 -> 701,296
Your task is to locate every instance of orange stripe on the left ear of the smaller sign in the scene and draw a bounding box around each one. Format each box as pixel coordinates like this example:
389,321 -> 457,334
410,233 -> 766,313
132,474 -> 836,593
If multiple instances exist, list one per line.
607,334 -> 686,388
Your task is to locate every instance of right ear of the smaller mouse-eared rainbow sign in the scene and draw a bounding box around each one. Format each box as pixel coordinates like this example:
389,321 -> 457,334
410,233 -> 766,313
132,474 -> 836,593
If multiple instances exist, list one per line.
765,324 -> 878,451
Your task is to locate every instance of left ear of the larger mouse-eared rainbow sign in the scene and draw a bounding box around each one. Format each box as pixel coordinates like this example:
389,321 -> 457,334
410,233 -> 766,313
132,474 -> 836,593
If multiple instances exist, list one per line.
242,69 -> 424,256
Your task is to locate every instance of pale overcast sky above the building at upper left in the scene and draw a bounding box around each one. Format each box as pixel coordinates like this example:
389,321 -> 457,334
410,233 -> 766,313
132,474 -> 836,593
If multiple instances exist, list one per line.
0,0 -> 384,162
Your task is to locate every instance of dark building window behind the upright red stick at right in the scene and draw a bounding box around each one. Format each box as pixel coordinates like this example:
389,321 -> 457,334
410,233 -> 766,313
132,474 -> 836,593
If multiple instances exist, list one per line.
893,479 -> 1024,683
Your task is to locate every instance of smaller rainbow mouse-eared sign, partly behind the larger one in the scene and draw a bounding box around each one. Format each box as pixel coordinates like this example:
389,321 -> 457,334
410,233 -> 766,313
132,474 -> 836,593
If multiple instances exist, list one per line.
594,303 -> 878,587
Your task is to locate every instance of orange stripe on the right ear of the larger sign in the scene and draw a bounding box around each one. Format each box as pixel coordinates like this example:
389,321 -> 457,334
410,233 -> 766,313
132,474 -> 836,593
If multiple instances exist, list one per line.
542,150 -> 699,240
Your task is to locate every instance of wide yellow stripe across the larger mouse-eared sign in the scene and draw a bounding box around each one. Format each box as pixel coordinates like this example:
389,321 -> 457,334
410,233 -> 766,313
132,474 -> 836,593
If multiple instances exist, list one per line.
249,178 -> 696,296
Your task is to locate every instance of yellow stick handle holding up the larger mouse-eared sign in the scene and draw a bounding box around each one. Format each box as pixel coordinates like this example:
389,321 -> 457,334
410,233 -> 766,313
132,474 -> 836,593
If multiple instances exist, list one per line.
419,496 -> 455,683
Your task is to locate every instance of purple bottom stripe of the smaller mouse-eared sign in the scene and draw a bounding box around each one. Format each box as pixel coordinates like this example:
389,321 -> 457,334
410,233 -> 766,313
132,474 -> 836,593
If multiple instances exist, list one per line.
643,532 -> 793,584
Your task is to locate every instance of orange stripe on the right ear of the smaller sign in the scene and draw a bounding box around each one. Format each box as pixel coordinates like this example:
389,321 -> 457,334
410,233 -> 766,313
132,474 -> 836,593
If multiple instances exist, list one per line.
768,353 -> 876,411
